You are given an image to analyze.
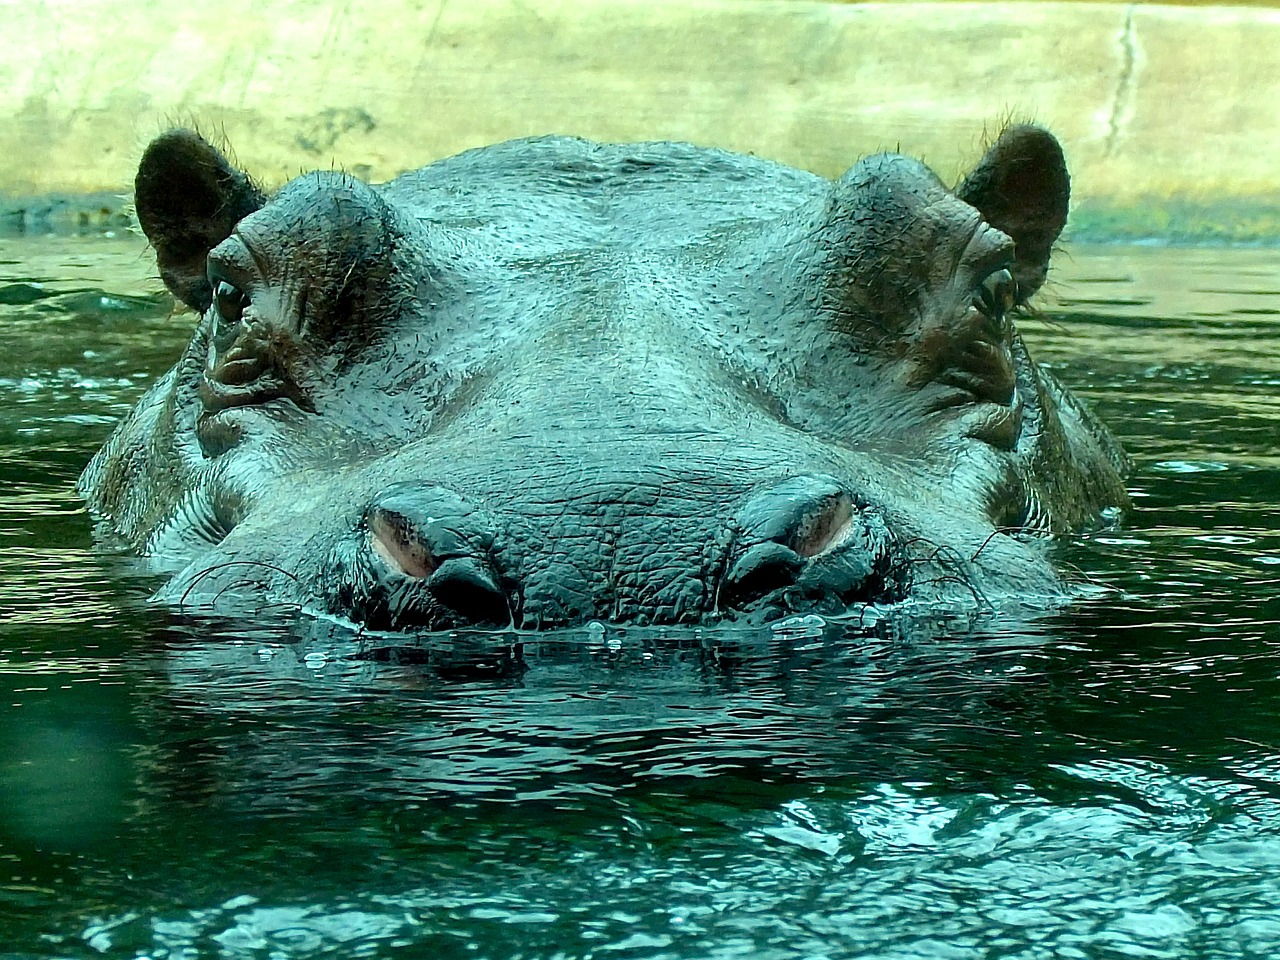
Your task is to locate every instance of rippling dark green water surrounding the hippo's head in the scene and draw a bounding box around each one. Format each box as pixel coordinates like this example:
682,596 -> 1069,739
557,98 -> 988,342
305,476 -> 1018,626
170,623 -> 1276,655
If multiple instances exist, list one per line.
0,238 -> 1280,960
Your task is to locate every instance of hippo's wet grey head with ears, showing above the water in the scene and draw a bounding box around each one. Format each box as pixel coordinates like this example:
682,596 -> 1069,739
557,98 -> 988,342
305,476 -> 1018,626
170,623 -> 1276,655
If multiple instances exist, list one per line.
81,125 -> 1126,631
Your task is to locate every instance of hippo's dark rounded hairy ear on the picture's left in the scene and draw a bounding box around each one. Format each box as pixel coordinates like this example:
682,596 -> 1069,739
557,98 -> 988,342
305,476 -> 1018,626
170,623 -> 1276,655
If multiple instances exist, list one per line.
133,129 -> 266,312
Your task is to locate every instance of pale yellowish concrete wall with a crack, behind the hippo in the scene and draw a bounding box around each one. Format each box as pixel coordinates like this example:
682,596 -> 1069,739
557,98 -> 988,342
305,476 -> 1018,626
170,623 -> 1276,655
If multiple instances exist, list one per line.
0,0 -> 1280,234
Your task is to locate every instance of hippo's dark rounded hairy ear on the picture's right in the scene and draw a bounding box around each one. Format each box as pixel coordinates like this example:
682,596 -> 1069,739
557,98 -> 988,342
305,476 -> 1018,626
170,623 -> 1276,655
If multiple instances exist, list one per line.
956,124 -> 1071,300
